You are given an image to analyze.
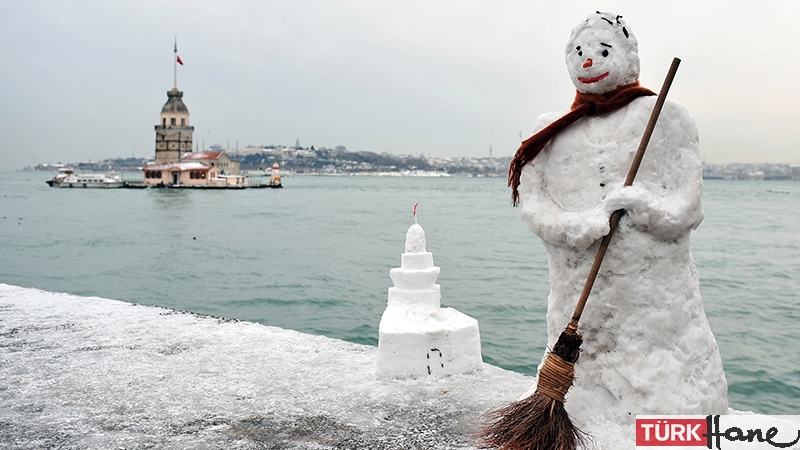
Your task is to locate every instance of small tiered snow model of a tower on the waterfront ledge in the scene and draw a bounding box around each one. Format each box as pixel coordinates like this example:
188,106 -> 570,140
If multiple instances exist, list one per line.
376,223 -> 483,378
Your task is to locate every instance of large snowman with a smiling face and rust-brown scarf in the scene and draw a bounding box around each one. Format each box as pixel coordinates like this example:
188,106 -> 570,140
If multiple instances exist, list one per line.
509,12 -> 728,448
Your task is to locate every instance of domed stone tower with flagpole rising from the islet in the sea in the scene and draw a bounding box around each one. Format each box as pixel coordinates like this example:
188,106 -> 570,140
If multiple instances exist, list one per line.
156,41 -> 194,164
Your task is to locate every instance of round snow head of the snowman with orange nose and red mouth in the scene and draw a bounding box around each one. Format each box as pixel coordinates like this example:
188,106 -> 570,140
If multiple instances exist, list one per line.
566,11 -> 639,94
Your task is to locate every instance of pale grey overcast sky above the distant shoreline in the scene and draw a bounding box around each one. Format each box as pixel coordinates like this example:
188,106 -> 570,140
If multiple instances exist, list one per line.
0,0 -> 800,170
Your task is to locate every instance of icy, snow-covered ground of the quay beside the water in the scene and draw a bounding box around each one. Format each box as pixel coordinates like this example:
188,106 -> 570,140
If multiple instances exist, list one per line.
0,284 -> 535,449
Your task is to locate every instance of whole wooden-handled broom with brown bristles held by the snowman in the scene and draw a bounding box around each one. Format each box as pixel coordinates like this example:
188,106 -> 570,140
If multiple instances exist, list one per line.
478,58 -> 681,450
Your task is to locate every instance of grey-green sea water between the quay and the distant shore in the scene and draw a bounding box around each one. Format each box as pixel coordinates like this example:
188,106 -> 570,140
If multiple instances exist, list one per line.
0,172 -> 800,414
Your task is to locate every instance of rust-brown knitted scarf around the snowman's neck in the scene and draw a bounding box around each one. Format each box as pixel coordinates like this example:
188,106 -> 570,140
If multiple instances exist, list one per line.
508,81 -> 656,206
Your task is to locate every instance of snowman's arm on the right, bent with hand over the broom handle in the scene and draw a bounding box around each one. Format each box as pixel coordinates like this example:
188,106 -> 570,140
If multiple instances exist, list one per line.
603,102 -> 703,240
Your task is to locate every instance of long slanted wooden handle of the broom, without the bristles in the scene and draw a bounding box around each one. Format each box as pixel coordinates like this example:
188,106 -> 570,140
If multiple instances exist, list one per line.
567,58 -> 681,332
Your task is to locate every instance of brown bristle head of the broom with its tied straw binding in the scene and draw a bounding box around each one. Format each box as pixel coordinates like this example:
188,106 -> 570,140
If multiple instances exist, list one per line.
478,327 -> 588,450
